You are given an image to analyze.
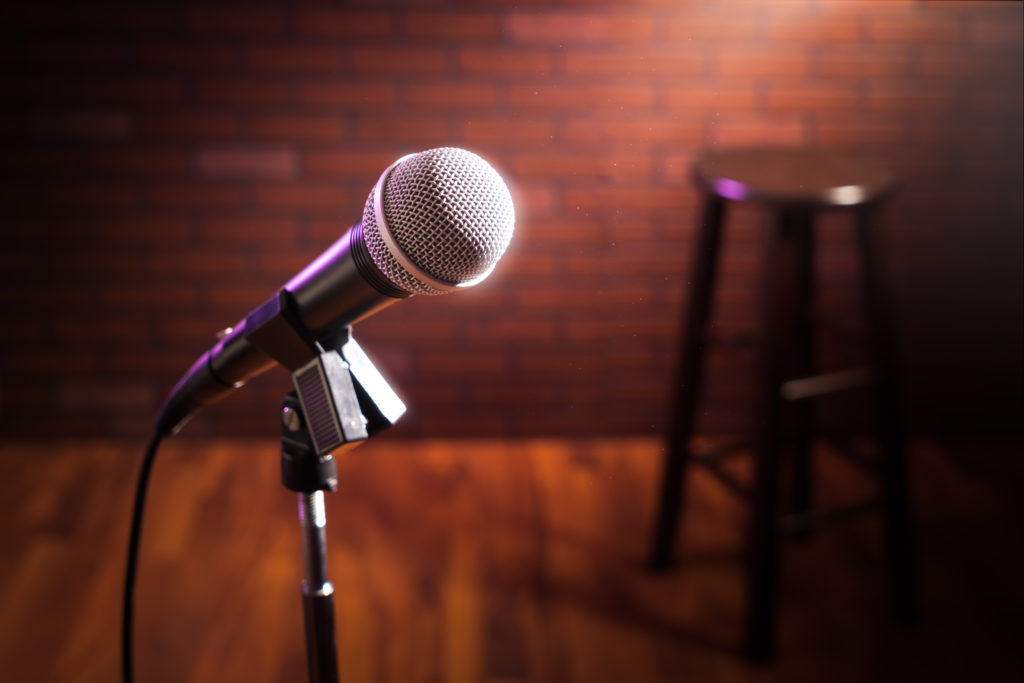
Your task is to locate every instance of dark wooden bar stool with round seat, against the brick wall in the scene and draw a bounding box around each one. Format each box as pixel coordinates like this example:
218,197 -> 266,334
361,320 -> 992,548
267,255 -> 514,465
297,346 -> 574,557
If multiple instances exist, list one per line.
650,148 -> 915,659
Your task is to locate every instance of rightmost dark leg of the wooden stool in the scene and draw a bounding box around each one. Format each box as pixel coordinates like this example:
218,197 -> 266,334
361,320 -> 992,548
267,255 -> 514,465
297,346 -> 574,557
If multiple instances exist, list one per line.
856,206 -> 916,622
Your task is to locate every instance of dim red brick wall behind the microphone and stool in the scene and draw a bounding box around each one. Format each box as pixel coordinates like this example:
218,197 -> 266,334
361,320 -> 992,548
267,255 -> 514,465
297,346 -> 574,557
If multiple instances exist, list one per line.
0,0 -> 1022,435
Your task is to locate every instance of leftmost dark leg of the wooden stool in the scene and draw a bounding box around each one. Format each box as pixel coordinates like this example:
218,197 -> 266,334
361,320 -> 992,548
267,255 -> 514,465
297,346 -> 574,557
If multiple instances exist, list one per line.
649,195 -> 725,569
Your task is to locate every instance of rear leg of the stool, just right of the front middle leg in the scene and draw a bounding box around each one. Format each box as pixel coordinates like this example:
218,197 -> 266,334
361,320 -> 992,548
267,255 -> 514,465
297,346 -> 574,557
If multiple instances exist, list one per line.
793,210 -> 814,536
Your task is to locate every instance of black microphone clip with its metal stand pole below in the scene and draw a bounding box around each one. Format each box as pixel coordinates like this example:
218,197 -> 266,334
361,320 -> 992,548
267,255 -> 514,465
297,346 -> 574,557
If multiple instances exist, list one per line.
247,291 -> 406,683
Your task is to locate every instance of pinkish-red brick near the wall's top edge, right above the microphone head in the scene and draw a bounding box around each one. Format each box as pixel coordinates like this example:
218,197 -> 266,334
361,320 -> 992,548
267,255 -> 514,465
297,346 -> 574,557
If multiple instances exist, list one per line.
504,11 -> 654,45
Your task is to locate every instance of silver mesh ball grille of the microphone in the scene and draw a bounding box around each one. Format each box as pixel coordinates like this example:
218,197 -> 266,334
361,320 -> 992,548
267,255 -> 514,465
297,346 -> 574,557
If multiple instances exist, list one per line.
362,147 -> 515,294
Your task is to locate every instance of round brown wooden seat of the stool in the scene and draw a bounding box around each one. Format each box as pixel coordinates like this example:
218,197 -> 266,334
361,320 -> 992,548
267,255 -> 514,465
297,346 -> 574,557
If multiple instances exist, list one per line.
694,147 -> 896,207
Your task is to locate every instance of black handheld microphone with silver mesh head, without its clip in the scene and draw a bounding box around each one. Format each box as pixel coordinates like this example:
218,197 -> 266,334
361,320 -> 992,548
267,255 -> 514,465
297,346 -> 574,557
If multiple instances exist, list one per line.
157,147 -> 515,435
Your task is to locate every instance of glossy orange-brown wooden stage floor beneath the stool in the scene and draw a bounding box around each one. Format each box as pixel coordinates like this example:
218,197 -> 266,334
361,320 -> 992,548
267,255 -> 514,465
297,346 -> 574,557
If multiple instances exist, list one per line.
0,438 -> 1024,683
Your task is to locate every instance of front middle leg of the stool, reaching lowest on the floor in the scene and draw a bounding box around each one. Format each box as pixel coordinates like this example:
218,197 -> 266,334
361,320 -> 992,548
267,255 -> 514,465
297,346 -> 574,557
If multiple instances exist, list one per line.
743,211 -> 796,660
